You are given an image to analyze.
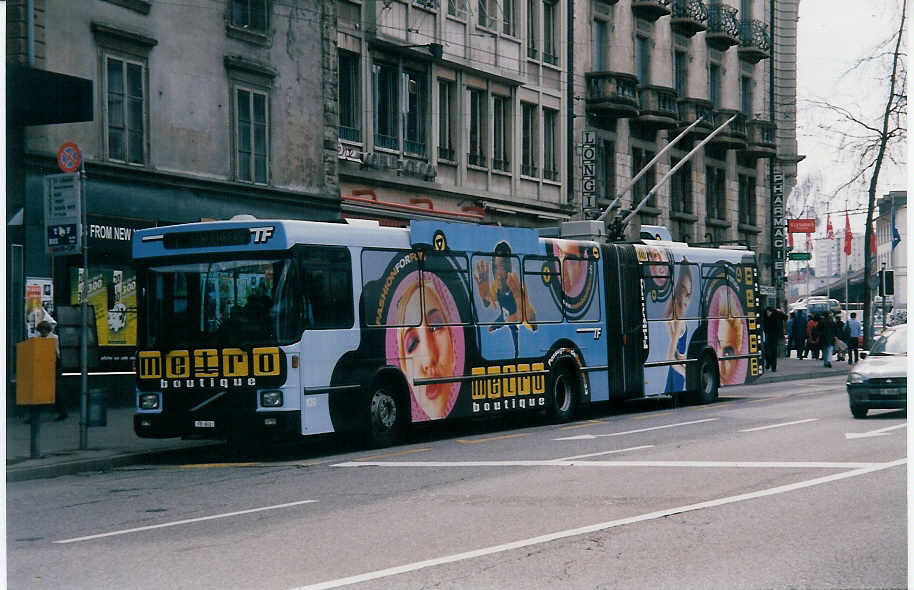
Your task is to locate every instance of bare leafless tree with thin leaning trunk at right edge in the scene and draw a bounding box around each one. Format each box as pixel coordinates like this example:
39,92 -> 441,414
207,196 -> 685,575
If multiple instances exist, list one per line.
809,0 -> 908,345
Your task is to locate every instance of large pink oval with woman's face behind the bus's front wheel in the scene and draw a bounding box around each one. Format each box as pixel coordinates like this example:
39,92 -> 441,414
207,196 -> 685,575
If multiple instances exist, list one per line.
385,271 -> 465,422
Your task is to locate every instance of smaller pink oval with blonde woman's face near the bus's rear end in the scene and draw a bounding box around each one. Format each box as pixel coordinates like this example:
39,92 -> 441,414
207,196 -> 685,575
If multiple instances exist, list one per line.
708,285 -> 749,385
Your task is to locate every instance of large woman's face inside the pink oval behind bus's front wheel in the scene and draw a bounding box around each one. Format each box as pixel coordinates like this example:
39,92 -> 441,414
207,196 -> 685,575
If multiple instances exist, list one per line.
399,288 -> 456,419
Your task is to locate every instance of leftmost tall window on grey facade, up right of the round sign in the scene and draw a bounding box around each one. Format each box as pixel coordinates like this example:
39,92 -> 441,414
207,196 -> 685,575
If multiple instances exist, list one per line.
105,56 -> 146,164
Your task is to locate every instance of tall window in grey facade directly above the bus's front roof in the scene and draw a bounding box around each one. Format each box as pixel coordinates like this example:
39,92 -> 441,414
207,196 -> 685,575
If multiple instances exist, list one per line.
235,87 -> 270,184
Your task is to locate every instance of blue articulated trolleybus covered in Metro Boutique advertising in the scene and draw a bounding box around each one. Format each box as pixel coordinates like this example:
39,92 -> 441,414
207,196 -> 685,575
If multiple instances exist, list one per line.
133,219 -> 762,446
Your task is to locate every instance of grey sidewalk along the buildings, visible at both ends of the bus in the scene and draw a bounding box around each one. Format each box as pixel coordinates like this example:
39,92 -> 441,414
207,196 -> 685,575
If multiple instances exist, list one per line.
6,358 -> 848,482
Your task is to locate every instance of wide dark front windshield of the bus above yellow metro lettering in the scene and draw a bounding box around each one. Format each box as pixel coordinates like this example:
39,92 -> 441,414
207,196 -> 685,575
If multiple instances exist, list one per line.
141,259 -> 301,348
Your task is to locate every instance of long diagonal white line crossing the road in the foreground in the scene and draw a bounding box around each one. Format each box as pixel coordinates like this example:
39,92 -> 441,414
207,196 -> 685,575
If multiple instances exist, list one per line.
295,459 -> 908,590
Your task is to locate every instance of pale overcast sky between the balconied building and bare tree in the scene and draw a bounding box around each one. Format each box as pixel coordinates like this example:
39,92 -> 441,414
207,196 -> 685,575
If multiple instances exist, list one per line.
797,0 -> 911,231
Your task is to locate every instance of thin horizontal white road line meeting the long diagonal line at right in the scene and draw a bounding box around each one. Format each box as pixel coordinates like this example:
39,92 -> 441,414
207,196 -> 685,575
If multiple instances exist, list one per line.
331,459 -> 882,469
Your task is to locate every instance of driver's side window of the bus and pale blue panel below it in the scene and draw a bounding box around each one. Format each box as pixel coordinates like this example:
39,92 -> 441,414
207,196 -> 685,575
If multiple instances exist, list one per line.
298,245 -> 359,434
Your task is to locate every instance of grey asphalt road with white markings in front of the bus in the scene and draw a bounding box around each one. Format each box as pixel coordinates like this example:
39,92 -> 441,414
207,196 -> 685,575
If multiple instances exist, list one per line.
7,377 -> 908,589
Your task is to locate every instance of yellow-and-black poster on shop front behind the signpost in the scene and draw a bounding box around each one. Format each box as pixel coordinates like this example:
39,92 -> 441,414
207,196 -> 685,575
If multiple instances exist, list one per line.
70,268 -> 136,347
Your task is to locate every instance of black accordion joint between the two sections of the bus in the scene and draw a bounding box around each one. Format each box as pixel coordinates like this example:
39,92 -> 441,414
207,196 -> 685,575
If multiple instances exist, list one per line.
603,244 -> 647,400
